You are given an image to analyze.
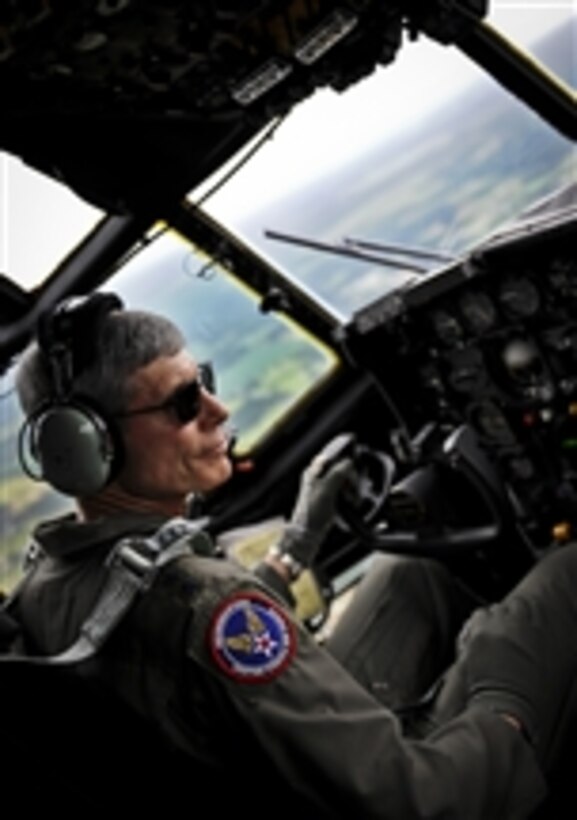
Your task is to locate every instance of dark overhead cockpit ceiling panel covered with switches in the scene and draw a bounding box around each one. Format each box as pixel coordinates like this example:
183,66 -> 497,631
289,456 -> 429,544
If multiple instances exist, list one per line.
0,0 -> 487,211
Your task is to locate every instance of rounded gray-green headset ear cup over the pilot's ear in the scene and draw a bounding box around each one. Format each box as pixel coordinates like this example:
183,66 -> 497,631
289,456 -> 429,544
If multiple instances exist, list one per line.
31,404 -> 120,497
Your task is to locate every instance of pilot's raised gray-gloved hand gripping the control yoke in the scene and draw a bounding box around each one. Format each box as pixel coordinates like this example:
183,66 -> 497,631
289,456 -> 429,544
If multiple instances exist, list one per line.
274,433 -> 355,567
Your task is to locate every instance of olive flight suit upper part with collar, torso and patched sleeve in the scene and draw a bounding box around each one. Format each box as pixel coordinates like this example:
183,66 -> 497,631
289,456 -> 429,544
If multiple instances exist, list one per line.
16,516 -> 545,820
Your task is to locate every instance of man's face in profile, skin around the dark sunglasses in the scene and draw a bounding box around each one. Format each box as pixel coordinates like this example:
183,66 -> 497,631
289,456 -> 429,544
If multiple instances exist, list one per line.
118,350 -> 232,501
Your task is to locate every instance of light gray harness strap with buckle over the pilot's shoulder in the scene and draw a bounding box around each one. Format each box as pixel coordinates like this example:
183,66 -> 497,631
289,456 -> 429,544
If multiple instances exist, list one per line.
0,518 -> 214,666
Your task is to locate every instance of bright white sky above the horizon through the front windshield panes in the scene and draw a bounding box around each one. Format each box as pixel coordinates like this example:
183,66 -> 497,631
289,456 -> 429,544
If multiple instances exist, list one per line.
199,0 -> 577,219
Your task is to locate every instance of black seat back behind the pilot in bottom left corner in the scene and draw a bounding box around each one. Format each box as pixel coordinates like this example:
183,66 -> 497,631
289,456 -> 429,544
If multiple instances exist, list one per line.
0,660 -> 198,818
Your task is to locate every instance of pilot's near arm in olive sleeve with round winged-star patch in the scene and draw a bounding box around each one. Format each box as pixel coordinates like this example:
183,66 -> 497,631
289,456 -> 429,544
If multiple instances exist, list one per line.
181,570 -> 544,820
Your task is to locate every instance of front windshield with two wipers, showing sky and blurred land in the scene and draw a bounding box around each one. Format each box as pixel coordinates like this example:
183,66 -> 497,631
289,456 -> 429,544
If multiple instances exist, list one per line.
190,3 -> 577,318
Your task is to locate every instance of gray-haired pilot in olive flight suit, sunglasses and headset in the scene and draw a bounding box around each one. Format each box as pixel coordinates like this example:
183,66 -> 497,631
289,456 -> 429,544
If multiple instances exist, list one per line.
12,294 -> 577,820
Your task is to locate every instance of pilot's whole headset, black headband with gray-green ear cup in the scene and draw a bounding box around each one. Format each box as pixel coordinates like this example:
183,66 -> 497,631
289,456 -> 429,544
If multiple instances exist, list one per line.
19,293 -> 123,497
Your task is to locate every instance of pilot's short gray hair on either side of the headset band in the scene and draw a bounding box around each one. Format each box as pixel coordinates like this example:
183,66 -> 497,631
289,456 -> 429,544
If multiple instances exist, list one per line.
16,310 -> 186,416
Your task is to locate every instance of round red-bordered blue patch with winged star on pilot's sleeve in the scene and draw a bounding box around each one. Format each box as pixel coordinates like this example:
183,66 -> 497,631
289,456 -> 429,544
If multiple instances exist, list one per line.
208,592 -> 296,683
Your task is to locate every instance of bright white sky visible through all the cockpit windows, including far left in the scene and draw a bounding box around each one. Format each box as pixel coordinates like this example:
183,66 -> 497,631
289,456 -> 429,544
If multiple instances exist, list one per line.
0,0 -> 577,288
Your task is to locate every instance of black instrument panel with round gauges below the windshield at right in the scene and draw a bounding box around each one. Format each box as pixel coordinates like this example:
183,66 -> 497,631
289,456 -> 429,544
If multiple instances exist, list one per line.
351,202 -> 577,550
